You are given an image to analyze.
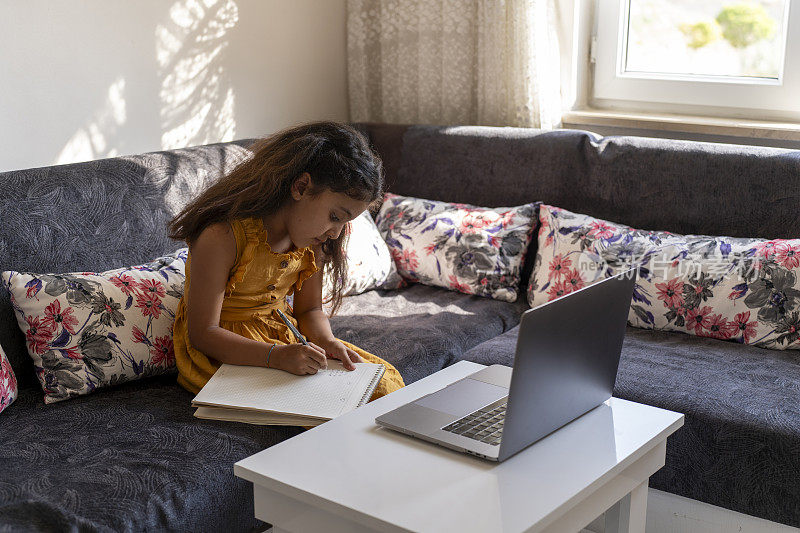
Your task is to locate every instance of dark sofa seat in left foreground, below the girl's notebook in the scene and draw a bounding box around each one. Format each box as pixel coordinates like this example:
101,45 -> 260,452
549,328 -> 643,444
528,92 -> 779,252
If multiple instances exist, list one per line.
0,376 -> 302,531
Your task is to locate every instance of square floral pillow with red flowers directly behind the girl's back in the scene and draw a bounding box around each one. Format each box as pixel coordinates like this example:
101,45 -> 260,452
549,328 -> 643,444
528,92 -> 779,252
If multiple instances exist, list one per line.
2,248 -> 187,403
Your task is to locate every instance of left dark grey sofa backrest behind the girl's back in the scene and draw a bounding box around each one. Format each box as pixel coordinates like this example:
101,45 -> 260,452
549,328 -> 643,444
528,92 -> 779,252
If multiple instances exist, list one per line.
0,139 -> 252,387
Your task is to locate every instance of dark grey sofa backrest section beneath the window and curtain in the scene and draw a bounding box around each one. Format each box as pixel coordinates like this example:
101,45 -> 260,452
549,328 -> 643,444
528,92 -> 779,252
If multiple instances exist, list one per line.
358,123 -> 800,238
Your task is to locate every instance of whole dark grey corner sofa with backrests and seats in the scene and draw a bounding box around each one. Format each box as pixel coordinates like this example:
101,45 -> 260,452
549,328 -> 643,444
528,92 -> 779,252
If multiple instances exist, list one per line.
0,124 -> 800,531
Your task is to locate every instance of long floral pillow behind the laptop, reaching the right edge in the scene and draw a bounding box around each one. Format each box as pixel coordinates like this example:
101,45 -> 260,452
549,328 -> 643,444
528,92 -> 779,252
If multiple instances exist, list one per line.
528,205 -> 800,350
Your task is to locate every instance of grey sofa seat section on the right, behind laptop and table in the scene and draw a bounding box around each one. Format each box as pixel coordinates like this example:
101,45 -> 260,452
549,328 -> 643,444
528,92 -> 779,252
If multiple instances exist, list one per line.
463,327 -> 800,527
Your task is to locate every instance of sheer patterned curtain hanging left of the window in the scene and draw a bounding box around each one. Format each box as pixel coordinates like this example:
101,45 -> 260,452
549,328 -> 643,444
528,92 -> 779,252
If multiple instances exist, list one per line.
347,0 -> 561,129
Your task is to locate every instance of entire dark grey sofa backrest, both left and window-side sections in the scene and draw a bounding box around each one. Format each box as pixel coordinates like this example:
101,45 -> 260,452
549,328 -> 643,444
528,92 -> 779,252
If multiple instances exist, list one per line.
6,123 -> 800,387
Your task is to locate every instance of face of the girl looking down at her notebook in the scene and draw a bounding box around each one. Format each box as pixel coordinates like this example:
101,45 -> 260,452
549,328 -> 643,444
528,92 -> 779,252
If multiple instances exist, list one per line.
286,172 -> 367,248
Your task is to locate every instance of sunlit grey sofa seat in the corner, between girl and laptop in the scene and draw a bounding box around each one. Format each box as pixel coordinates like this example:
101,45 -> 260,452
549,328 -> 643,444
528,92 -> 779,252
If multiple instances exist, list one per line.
330,285 -> 528,383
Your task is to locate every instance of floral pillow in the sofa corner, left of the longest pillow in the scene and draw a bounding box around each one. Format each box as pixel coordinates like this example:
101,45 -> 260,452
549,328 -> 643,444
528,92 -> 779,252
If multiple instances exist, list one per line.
375,194 -> 536,302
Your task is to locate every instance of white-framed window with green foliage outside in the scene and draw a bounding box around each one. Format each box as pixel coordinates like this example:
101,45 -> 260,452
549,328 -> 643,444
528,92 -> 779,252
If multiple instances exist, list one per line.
592,0 -> 800,121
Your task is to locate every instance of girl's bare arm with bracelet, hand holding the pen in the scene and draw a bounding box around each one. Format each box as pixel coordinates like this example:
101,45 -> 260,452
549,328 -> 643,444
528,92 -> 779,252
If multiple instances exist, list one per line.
186,222 -> 327,374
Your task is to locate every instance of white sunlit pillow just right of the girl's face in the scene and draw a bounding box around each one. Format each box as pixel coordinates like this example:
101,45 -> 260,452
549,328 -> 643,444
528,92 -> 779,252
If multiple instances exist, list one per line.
323,211 -> 405,299
